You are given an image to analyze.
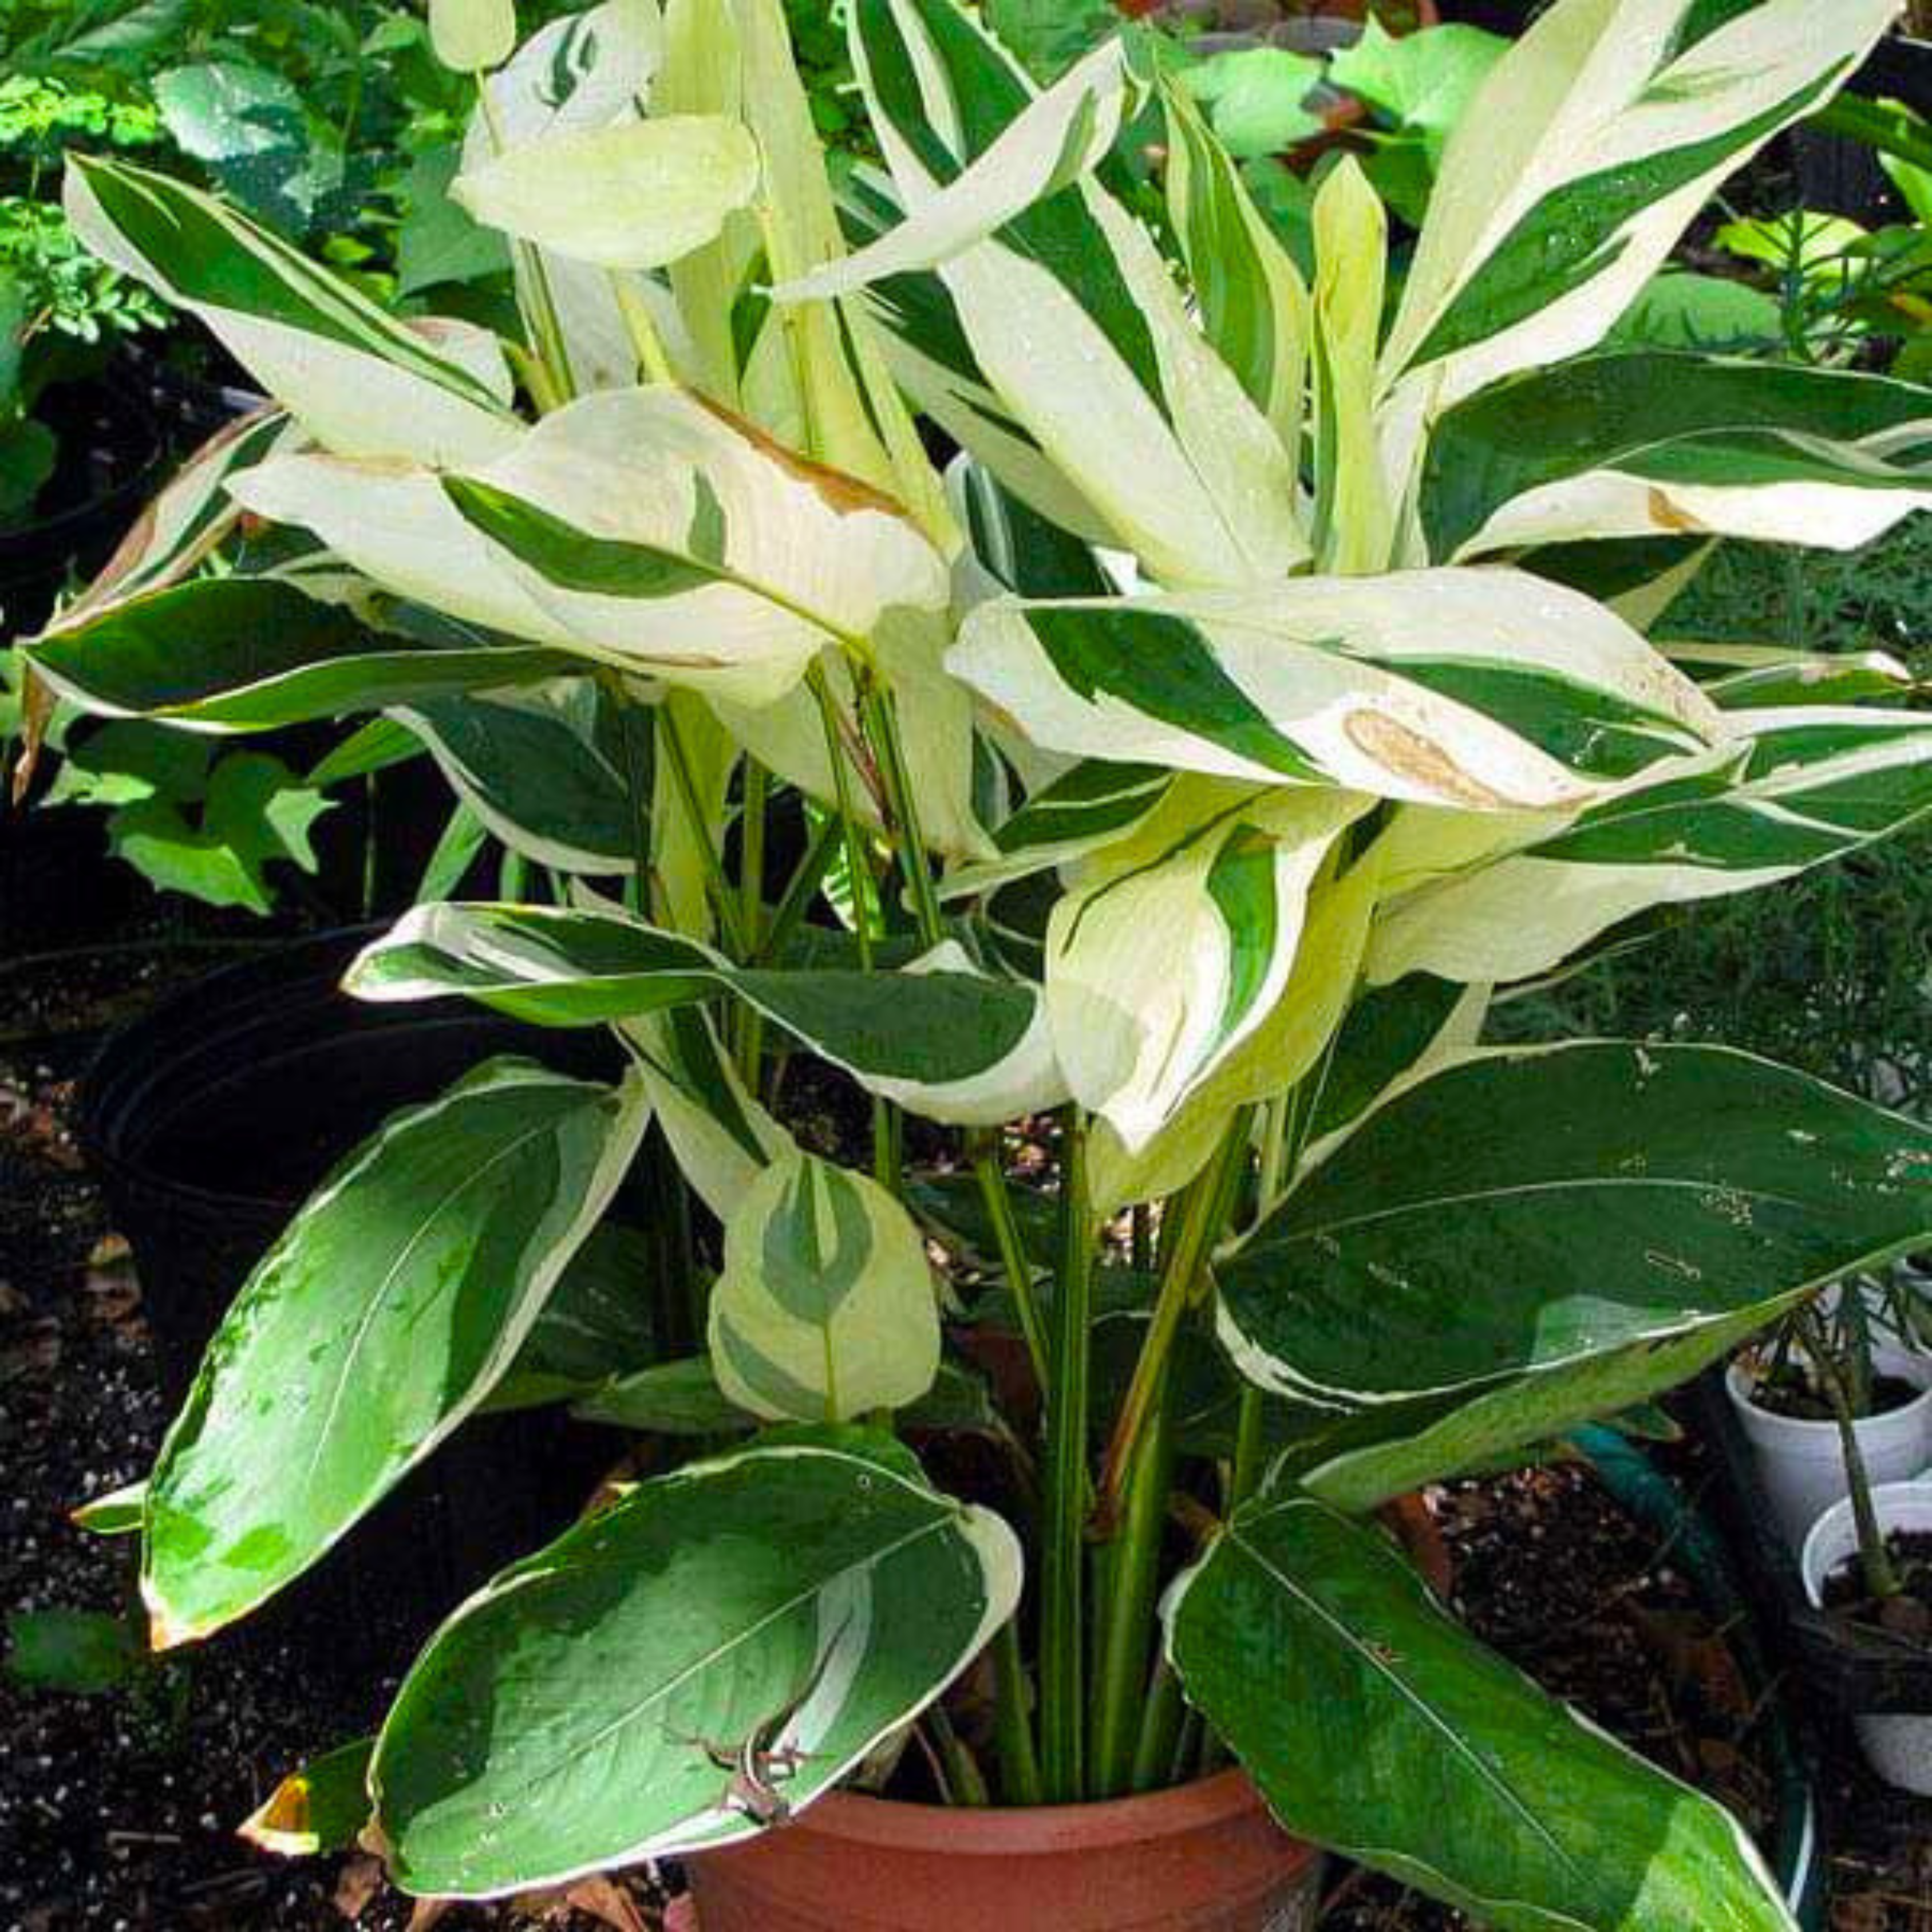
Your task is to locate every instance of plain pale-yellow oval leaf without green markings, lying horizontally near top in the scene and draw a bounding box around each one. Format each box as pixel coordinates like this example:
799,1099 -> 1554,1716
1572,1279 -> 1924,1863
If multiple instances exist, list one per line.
450,114 -> 757,268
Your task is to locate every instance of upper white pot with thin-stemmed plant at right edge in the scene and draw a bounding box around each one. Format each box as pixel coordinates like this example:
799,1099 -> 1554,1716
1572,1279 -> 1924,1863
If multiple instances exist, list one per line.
1725,1269 -> 1932,1551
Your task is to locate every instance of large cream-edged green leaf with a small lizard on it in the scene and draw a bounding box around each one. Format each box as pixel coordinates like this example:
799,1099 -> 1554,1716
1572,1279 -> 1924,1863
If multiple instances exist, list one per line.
371,1432 -> 1020,1897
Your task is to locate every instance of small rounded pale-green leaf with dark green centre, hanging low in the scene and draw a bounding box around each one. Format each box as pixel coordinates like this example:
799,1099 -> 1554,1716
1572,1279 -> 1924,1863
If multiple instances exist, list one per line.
709,1153 -> 939,1422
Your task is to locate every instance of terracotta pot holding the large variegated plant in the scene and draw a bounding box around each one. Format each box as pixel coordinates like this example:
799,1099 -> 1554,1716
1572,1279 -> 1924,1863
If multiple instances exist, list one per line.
690,1772 -> 1322,1932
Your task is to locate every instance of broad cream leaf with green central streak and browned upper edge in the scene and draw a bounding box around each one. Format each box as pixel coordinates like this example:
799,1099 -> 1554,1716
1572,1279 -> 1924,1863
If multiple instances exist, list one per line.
243,388 -> 949,705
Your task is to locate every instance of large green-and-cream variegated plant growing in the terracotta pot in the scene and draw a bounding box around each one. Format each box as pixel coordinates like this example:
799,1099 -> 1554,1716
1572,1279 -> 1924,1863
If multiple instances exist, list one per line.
31,0 -> 1932,1932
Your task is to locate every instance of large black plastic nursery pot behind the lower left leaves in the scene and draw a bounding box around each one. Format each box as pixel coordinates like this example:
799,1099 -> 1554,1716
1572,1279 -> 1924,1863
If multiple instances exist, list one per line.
81,927 -> 617,1671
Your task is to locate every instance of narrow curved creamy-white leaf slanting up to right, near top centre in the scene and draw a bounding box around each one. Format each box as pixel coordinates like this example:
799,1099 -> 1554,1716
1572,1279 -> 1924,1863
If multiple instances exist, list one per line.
773,37 -> 1142,302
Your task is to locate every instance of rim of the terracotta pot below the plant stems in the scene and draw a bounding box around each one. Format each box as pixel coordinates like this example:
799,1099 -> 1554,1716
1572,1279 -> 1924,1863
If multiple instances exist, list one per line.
765,1768 -> 1314,1859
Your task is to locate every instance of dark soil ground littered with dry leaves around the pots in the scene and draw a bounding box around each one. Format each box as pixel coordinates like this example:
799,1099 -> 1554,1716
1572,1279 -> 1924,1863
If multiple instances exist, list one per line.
0,951 -> 1932,1932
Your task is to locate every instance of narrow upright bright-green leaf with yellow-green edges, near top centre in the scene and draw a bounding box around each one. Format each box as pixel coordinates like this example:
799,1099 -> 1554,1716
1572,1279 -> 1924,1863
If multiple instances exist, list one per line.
1159,81 -> 1312,465
